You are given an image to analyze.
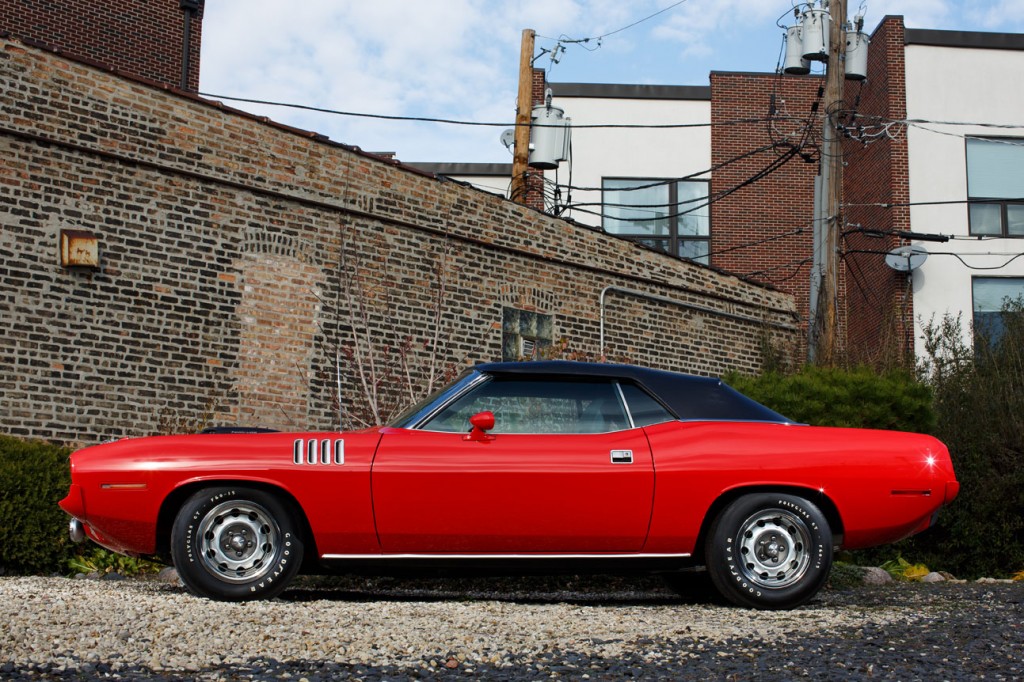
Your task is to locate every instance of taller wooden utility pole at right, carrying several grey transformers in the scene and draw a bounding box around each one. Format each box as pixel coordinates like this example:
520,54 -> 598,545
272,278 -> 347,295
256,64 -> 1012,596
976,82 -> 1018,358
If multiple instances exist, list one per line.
810,0 -> 846,365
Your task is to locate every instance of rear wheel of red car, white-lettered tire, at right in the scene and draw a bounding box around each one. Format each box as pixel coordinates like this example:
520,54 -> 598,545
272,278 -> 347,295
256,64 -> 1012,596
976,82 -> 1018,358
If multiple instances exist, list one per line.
705,494 -> 833,608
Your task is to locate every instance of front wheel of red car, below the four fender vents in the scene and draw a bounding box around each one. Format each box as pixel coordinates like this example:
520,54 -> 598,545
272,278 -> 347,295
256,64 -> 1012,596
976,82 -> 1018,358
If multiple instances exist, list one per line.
171,486 -> 302,601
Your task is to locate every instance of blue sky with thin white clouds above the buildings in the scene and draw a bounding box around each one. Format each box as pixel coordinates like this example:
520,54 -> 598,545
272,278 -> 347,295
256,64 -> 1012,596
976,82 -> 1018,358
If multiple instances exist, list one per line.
200,0 -> 1024,163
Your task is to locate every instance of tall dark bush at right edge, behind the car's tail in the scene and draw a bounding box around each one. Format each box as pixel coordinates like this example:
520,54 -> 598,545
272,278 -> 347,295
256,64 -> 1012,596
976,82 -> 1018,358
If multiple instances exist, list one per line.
899,301 -> 1024,579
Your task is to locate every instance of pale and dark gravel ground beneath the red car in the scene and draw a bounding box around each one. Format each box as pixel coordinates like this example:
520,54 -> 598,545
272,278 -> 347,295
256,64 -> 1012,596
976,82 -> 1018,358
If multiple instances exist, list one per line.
0,577 -> 1024,682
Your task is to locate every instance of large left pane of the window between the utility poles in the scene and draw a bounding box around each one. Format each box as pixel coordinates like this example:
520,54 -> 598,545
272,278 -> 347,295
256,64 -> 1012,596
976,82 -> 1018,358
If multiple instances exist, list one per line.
602,179 -> 676,236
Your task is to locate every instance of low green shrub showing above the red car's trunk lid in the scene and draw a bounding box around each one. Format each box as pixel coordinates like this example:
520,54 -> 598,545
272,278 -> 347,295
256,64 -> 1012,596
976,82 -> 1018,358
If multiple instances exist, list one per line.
726,367 -> 935,432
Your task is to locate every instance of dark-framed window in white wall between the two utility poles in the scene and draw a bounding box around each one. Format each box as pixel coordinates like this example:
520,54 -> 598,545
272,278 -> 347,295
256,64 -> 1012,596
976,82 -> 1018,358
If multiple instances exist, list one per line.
601,178 -> 711,263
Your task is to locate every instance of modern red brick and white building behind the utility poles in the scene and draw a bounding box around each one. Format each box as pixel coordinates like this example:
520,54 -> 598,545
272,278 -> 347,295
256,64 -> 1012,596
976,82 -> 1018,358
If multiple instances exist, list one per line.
436,16 -> 978,366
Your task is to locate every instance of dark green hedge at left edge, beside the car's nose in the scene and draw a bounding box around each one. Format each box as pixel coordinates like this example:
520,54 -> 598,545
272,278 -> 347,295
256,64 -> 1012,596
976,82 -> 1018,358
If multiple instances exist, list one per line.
0,435 -> 74,574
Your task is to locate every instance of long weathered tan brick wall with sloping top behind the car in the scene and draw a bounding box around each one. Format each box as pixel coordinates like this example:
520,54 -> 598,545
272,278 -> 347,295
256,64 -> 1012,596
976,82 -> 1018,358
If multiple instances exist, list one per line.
0,40 -> 796,441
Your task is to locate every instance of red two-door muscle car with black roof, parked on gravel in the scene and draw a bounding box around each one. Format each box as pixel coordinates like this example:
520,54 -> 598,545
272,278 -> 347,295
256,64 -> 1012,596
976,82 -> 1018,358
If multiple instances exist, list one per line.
60,361 -> 959,608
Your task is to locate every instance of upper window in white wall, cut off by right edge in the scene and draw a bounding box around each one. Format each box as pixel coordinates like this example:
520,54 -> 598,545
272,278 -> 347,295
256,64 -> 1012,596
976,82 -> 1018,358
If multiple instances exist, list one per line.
967,137 -> 1024,237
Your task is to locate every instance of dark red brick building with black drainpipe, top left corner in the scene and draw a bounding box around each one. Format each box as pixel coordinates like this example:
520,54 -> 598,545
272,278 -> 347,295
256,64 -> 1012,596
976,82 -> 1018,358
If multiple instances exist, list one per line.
0,0 -> 205,91
